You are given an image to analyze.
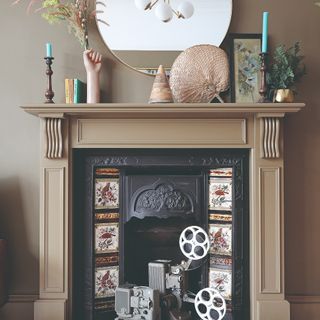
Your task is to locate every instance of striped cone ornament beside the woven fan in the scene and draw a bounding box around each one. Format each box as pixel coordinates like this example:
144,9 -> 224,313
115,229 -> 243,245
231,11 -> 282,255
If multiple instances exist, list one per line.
149,65 -> 173,103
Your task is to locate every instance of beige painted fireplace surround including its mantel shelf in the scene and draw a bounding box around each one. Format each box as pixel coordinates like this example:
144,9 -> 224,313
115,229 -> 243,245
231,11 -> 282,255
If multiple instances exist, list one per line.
23,104 -> 304,320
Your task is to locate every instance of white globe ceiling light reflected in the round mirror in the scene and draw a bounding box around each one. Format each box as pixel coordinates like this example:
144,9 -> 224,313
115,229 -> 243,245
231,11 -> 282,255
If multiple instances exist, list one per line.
134,0 -> 194,22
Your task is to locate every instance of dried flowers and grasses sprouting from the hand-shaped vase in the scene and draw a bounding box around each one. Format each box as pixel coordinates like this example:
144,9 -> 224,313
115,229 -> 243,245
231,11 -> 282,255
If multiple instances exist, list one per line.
13,0 -> 107,49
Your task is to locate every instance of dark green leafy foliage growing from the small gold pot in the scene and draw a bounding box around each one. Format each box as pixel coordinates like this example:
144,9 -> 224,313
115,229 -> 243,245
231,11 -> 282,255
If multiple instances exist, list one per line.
268,42 -> 306,90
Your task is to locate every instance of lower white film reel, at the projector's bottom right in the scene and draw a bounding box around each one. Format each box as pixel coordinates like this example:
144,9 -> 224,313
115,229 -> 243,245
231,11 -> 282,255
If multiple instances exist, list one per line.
194,288 -> 227,320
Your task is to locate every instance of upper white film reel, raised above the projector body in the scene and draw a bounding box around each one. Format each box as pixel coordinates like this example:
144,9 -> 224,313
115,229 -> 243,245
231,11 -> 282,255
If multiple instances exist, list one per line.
179,226 -> 210,260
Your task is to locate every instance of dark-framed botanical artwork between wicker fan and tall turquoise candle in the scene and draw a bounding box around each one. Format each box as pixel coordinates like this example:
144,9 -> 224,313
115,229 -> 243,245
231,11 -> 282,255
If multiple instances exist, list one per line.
229,33 -> 261,103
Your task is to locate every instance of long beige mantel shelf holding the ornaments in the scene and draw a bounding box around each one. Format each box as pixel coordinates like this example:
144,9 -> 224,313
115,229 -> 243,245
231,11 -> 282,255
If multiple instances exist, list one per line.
22,103 -> 305,118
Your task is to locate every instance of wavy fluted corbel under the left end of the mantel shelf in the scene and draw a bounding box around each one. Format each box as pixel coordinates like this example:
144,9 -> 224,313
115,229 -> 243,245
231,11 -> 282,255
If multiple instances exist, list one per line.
39,113 -> 65,159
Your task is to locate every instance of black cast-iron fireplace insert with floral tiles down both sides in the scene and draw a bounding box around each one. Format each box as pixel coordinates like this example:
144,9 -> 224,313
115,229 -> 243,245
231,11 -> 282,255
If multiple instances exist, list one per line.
72,149 -> 250,320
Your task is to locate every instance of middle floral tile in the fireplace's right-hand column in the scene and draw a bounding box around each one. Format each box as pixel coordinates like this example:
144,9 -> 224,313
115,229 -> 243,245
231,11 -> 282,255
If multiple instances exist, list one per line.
209,224 -> 232,256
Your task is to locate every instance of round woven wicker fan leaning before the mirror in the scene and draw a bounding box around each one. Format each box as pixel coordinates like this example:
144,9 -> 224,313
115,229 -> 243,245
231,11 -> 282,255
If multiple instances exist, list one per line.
170,45 -> 229,103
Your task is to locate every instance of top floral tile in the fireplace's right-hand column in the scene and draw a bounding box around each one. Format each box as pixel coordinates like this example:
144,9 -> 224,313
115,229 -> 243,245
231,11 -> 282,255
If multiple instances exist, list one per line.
209,177 -> 232,211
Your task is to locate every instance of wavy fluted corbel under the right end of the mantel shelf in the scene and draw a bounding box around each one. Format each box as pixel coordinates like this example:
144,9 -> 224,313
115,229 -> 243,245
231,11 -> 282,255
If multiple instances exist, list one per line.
257,113 -> 285,159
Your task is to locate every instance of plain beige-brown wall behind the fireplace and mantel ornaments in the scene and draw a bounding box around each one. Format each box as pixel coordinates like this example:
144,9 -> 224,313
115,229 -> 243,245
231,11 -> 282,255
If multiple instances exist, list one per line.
0,0 -> 320,320
